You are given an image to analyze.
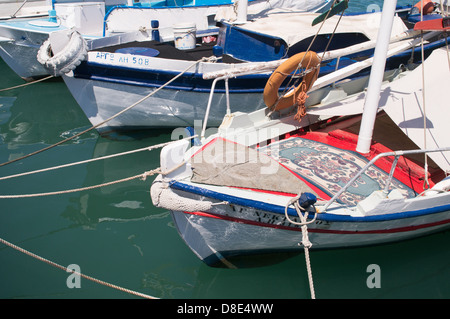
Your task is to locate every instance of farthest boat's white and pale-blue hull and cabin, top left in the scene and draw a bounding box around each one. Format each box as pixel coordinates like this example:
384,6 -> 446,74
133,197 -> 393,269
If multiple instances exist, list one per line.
0,0 -> 329,79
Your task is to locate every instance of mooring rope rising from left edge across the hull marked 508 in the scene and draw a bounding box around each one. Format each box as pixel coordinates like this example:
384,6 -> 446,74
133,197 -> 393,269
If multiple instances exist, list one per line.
0,56 -> 217,167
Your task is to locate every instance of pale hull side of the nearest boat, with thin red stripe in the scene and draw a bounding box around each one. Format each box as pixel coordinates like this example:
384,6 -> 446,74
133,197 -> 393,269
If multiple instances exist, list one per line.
172,192 -> 450,267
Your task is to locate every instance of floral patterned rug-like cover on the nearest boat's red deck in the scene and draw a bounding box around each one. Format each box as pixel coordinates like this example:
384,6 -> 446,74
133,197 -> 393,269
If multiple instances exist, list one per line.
259,137 -> 415,205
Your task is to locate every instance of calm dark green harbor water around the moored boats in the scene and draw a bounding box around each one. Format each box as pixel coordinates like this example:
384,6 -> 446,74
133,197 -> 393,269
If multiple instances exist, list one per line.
0,0 -> 450,299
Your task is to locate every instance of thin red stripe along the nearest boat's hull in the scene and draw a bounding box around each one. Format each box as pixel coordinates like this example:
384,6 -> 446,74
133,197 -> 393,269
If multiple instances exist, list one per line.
184,212 -> 450,235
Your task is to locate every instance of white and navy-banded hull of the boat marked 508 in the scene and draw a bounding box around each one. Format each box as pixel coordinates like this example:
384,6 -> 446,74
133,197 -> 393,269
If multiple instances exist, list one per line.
62,35 -> 444,134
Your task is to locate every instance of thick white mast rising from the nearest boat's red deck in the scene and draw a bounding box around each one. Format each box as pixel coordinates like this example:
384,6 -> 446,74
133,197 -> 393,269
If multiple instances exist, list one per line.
356,0 -> 397,154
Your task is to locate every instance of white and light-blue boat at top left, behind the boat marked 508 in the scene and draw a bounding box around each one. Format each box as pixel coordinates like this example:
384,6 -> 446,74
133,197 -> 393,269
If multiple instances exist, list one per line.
0,0 -> 322,80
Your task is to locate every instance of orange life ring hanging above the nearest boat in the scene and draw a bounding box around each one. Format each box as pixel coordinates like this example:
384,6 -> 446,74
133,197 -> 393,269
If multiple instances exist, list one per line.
263,51 -> 320,119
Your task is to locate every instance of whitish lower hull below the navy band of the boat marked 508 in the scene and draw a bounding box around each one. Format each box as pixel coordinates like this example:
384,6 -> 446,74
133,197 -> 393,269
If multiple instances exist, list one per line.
63,72 -> 264,133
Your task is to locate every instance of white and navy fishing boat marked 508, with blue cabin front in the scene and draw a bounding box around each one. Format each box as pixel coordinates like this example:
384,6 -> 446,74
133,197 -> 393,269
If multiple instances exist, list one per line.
55,0 -> 444,134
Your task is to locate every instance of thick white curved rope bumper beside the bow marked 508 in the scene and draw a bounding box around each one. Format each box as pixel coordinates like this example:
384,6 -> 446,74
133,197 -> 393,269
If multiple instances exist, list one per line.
37,31 -> 88,76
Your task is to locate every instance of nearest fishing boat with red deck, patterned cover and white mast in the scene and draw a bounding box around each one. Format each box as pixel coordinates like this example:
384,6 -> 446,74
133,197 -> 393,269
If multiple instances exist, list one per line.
151,1 -> 450,267
